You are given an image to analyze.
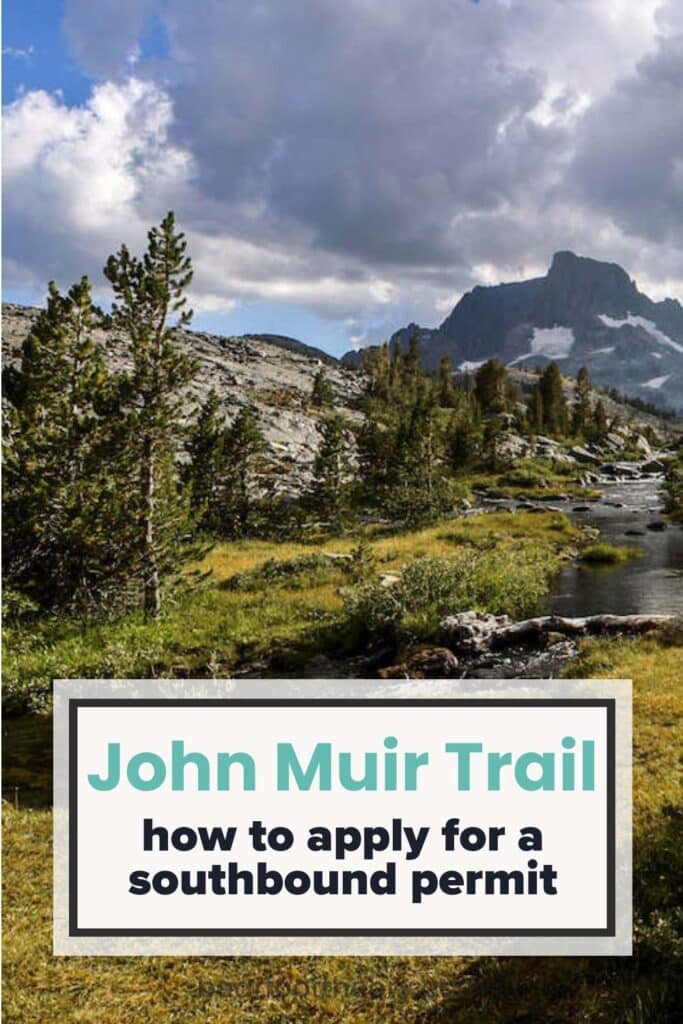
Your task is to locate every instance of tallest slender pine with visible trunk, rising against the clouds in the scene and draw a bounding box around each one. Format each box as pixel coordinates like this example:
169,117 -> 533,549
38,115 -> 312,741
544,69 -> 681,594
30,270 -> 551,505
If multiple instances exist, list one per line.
104,212 -> 195,616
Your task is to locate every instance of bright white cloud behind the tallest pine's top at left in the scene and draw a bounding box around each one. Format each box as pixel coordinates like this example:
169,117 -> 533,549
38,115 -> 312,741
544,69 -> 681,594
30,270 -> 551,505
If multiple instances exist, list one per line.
3,78 -> 405,316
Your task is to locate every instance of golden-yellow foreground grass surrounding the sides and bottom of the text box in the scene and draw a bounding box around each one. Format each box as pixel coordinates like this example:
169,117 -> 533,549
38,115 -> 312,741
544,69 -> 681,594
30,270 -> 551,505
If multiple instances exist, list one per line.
4,630 -> 683,1024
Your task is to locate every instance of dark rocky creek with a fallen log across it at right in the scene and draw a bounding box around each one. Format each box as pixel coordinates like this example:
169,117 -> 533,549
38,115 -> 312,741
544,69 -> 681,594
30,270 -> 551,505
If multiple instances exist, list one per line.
428,464 -> 683,678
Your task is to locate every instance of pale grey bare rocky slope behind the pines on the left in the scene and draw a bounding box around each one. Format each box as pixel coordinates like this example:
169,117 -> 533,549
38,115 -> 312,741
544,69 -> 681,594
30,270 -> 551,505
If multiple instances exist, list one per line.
2,304 -> 361,492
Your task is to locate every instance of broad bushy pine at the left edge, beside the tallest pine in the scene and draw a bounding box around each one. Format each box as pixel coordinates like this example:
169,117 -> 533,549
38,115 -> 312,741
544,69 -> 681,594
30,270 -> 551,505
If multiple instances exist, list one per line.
3,278 -> 126,608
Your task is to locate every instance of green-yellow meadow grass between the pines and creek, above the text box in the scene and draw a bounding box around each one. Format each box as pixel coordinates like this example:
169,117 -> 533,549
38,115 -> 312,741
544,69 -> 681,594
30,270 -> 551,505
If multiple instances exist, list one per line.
3,512 -> 580,713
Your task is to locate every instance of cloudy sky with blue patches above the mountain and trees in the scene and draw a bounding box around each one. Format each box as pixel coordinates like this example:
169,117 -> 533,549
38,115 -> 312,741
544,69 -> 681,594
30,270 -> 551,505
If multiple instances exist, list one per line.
3,0 -> 683,353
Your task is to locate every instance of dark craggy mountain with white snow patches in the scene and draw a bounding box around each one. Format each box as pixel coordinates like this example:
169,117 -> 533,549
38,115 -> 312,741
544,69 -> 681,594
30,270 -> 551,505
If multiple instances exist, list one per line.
342,252 -> 683,413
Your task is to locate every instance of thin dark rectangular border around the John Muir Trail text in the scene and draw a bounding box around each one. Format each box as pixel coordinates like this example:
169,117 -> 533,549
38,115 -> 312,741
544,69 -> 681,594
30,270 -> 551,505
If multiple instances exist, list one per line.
69,697 -> 616,938
